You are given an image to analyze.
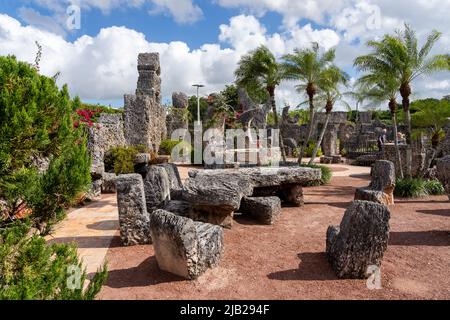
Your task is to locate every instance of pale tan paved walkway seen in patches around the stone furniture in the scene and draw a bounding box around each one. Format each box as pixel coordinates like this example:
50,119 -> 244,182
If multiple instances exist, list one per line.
47,165 -> 370,274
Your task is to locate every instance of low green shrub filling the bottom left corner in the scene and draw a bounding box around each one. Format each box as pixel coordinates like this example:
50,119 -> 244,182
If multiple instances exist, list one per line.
0,223 -> 107,300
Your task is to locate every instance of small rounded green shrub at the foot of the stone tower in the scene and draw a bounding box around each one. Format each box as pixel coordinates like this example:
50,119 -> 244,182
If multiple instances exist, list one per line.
105,146 -> 156,175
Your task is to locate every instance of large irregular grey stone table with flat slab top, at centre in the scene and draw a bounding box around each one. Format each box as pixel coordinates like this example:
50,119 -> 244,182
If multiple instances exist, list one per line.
182,167 -> 321,228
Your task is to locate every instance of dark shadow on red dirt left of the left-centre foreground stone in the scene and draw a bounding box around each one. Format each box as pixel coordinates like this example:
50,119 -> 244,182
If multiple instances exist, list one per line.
105,256 -> 186,289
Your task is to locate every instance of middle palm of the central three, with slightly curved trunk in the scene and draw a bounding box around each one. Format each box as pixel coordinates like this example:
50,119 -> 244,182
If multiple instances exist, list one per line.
283,43 -> 336,164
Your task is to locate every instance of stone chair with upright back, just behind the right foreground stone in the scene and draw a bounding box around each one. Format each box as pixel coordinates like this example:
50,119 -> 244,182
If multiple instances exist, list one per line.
355,160 -> 395,205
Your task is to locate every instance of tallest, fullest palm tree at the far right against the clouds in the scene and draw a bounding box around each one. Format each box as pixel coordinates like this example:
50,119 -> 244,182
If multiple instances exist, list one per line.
355,24 -> 448,176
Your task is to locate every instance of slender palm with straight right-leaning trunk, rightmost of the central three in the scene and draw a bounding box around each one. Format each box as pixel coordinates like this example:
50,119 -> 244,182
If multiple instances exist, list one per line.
309,65 -> 349,165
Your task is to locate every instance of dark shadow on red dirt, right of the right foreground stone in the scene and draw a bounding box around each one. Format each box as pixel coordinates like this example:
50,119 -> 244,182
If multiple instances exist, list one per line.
389,230 -> 450,247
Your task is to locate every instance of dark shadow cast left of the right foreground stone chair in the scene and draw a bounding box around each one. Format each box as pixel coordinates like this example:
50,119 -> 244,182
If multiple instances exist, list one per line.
267,252 -> 338,281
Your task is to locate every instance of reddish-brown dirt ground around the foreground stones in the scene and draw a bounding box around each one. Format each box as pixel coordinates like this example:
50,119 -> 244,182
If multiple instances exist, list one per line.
99,172 -> 450,300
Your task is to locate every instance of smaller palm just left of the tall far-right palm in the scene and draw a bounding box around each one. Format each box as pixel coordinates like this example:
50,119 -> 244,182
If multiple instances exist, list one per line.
357,73 -> 404,179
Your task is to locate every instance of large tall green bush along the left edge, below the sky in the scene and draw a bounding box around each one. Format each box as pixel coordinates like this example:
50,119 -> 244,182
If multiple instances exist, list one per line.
0,57 -> 90,233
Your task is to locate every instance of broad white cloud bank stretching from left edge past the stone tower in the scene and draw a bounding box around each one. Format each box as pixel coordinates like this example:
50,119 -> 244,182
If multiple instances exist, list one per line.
0,15 -> 339,107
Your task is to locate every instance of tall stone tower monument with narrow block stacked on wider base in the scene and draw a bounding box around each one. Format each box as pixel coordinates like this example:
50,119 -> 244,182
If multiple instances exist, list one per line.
124,53 -> 166,152
